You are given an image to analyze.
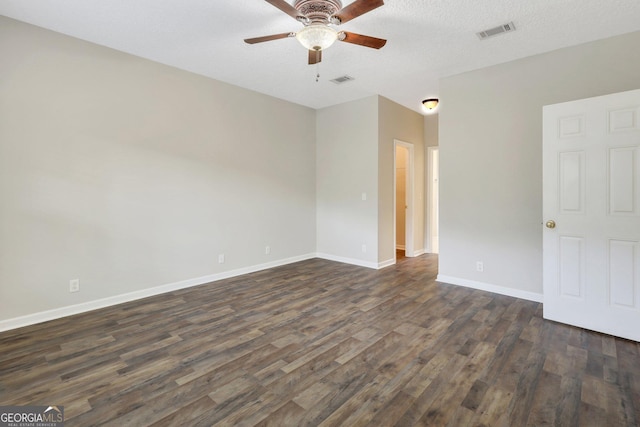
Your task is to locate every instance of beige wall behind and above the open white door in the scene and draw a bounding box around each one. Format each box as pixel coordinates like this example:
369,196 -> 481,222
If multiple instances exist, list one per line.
439,32 -> 640,299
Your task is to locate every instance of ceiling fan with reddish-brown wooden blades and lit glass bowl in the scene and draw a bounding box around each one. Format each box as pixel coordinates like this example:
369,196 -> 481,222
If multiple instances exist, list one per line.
244,0 -> 387,64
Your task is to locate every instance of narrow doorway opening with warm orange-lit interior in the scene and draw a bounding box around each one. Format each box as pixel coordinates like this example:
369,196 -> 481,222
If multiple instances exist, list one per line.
393,140 -> 415,257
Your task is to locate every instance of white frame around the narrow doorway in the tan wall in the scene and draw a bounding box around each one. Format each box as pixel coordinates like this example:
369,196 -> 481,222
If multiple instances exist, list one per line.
393,139 -> 416,260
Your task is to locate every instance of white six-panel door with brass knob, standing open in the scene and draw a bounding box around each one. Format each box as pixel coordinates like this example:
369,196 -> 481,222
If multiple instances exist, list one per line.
543,90 -> 640,341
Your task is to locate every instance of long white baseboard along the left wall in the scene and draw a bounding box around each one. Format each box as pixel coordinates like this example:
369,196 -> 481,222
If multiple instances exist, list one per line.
0,253 -> 316,332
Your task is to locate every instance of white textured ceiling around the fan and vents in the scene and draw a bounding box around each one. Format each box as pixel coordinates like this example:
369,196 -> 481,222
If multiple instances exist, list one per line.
0,0 -> 640,112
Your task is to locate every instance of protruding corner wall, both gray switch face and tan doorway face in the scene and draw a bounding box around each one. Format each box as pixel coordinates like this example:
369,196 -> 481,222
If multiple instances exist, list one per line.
316,96 -> 424,268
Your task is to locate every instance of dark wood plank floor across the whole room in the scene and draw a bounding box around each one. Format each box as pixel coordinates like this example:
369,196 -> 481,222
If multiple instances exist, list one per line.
0,255 -> 640,426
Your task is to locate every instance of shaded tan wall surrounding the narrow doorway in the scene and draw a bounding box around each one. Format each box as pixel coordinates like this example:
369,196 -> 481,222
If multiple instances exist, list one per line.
378,96 -> 425,265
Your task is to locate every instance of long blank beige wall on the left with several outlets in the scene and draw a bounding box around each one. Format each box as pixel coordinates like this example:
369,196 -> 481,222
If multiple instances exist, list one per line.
0,17 -> 318,322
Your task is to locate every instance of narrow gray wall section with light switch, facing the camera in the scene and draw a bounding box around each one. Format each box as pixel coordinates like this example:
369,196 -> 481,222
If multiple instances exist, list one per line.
316,96 -> 378,267
